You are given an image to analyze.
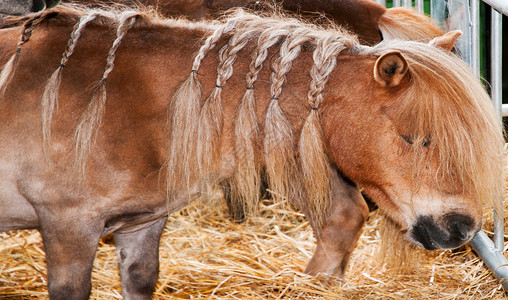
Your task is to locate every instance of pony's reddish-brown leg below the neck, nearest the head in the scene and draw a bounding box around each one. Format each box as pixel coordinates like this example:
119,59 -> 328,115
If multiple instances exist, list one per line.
305,170 -> 369,277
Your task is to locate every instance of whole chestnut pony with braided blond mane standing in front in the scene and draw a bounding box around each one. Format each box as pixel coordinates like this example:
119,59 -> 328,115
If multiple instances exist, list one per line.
0,6 -> 503,299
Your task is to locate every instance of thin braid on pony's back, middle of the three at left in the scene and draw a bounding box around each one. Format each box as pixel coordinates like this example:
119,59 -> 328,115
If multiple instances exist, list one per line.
42,12 -> 99,155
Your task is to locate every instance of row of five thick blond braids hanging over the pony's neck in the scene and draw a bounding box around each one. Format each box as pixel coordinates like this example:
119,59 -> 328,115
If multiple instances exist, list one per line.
167,11 -> 357,222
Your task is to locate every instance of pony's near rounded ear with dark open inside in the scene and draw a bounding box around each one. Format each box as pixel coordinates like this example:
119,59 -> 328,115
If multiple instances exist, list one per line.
374,51 -> 408,87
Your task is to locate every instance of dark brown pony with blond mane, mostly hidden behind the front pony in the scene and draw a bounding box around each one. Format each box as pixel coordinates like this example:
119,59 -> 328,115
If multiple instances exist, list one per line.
66,0 -> 443,45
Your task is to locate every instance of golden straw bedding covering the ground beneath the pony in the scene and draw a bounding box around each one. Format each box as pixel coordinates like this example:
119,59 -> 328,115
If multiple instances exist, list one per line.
0,157 -> 508,299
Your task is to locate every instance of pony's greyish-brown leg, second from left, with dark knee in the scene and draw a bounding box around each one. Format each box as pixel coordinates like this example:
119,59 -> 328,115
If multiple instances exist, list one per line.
115,217 -> 166,300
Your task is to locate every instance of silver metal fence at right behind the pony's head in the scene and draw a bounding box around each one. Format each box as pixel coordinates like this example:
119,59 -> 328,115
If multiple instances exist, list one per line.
376,0 -> 508,291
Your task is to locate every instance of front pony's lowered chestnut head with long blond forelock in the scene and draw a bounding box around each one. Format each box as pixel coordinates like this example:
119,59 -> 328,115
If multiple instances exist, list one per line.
323,32 -> 504,249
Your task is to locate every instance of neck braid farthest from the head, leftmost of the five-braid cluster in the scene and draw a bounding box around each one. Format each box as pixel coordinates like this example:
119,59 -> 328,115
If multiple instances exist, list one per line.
166,14 -> 247,199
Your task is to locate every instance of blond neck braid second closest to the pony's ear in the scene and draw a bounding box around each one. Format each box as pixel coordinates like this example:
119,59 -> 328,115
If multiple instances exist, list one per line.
264,28 -> 311,201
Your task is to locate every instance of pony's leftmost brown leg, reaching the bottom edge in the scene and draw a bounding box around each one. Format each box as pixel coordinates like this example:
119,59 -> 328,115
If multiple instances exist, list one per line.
39,209 -> 103,300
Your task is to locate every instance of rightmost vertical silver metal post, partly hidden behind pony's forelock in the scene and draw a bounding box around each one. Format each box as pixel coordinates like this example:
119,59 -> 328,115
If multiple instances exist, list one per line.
490,8 -> 504,252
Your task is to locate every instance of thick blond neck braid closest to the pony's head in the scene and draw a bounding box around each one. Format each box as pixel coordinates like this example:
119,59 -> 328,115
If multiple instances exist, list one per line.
298,35 -> 354,226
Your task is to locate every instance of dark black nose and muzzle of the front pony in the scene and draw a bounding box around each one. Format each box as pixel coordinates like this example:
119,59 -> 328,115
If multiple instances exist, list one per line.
409,213 -> 480,250
